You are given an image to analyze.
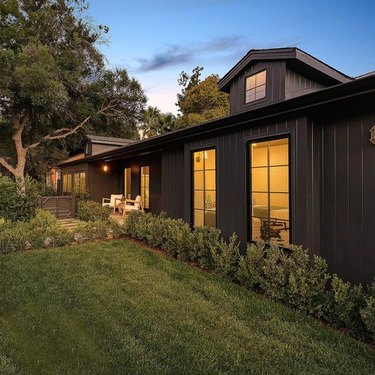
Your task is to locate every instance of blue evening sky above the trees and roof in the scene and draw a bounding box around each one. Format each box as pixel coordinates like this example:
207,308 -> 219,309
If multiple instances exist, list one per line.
89,0 -> 375,113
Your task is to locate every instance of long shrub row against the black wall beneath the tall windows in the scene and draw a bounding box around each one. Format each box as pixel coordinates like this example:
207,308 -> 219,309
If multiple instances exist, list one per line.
124,211 -> 375,341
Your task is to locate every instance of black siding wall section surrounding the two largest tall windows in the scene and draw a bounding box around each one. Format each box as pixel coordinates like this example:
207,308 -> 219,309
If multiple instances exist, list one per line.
179,117 -> 319,253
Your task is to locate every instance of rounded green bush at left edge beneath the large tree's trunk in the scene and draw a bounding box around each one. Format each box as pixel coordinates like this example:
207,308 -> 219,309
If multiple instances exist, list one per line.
0,176 -> 38,221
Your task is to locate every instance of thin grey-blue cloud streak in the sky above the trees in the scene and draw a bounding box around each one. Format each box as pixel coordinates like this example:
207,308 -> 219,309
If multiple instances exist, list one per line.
137,36 -> 244,73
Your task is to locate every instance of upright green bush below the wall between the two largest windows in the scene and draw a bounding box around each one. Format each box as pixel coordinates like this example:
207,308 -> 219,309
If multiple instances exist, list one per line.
211,234 -> 240,280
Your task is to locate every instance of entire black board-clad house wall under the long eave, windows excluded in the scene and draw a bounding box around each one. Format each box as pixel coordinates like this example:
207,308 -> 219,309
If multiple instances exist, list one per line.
65,97 -> 375,283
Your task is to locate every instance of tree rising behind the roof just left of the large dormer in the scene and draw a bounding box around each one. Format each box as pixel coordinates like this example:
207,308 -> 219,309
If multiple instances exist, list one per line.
176,67 -> 229,128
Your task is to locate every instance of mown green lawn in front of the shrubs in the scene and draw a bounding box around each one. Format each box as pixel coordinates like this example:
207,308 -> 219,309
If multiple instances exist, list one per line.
0,241 -> 375,375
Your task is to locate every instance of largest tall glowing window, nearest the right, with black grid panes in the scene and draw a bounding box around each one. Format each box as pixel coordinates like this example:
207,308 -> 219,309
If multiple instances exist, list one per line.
250,138 -> 290,246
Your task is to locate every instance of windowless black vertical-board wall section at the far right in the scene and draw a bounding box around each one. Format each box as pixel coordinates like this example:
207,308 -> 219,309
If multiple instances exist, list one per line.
316,98 -> 375,283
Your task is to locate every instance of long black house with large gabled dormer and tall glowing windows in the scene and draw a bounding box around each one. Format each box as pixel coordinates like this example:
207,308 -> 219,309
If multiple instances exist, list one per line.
61,48 -> 375,283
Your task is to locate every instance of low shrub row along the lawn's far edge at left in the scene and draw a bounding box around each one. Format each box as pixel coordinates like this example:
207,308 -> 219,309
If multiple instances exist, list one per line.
0,209 -> 123,254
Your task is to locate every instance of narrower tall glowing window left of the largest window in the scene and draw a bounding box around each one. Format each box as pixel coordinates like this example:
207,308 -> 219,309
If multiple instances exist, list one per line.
193,149 -> 216,227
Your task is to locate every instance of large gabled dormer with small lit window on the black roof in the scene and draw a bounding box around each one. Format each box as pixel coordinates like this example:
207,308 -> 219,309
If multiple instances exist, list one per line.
219,48 -> 352,114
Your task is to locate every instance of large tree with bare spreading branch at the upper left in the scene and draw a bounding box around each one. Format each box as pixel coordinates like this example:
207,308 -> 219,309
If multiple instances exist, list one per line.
0,0 -> 146,188
